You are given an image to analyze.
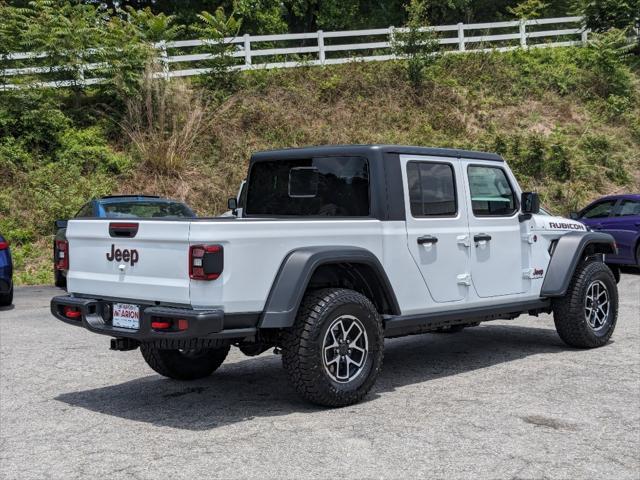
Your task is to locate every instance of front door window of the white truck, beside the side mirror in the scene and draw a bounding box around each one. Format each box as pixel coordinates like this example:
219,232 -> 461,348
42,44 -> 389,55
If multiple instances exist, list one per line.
467,165 -> 517,217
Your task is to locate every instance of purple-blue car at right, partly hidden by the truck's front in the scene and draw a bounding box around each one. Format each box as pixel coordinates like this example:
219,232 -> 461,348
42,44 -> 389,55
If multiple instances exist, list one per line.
570,193 -> 640,267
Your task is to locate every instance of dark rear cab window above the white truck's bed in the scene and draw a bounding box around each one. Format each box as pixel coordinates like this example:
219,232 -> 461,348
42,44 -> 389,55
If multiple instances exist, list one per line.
245,157 -> 369,217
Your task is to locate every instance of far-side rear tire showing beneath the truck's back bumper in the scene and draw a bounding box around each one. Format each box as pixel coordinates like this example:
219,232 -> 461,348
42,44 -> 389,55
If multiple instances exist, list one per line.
140,343 -> 229,380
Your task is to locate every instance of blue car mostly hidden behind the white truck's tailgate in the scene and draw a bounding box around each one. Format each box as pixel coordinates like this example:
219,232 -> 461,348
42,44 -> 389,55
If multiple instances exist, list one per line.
53,195 -> 196,288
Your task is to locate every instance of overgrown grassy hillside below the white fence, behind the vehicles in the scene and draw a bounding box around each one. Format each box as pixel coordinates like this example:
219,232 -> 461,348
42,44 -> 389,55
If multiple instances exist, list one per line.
0,45 -> 640,283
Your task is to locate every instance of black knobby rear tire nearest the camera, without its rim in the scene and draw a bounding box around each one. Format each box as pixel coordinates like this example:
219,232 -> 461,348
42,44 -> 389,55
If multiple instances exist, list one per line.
282,288 -> 384,407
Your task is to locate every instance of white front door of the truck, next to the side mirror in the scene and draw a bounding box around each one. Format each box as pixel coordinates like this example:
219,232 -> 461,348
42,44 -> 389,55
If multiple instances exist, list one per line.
462,161 -> 526,297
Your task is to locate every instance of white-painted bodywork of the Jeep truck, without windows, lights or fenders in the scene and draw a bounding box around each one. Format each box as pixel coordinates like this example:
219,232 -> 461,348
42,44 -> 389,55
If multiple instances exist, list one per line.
67,155 -> 584,315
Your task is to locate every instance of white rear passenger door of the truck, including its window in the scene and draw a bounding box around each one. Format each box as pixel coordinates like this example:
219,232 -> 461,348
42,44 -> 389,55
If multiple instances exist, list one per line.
400,155 -> 470,302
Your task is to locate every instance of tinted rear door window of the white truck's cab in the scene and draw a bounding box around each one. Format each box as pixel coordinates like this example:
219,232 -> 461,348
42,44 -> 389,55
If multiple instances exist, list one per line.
407,162 -> 458,217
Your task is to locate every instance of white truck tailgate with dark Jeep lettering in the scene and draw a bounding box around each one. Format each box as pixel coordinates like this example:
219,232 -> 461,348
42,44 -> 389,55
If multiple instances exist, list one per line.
67,219 -> 191,304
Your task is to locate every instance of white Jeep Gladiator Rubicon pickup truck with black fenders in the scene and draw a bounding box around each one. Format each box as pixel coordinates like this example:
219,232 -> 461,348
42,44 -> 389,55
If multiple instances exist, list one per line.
51,145 -> 618,406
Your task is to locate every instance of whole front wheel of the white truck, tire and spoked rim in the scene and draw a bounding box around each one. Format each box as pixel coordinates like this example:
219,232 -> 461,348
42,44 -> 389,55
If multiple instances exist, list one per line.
553,262 -> 618,348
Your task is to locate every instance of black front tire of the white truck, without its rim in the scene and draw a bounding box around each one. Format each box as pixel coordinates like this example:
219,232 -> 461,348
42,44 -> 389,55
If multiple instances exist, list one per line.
553,262 -> 618,348
